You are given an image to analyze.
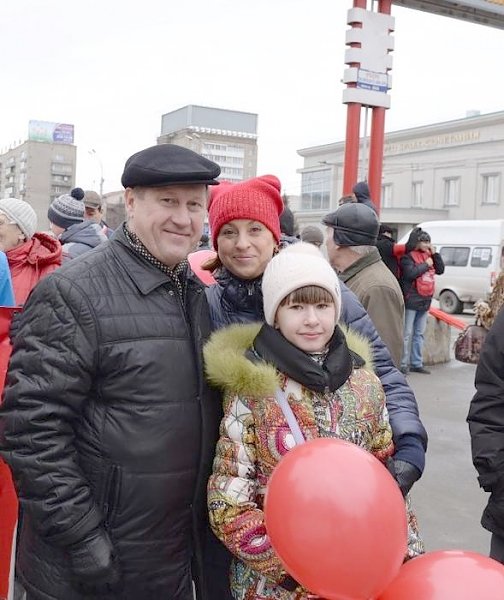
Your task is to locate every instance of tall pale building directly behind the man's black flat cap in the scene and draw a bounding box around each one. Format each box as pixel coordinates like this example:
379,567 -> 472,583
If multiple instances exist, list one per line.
157,104 -> 257,181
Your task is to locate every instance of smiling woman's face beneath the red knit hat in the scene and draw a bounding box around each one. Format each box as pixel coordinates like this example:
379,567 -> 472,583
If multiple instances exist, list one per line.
217,219 -> 276,279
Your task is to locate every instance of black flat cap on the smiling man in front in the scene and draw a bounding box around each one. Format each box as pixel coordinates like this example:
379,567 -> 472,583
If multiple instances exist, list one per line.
121,144 -> 220,188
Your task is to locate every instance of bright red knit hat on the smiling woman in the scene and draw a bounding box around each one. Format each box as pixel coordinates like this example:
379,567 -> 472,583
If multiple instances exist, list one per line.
208,175 -> 284,248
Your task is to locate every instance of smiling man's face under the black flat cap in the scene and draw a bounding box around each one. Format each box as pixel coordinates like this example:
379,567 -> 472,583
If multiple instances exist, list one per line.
125,184 -> 207,267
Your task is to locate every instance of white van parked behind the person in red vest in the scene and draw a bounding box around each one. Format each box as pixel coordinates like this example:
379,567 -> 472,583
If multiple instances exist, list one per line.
399,219 -> 504,314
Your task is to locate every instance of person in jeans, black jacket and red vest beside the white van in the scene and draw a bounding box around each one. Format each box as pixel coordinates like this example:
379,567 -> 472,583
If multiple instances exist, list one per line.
401,227 -> 444,375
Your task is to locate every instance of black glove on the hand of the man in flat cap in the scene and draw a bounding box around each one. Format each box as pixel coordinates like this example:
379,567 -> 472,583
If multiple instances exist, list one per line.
67,529 -> 121,596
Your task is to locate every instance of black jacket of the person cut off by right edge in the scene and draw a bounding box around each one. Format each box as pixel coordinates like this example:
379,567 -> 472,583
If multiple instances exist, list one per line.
467,310 -> 504,538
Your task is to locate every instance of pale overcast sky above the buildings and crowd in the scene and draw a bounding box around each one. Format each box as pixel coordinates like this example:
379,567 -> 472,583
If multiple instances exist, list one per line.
0,0 -> 504,194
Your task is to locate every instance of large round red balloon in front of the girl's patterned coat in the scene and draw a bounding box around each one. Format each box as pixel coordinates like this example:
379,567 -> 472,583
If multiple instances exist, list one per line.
264,438 -> 407,600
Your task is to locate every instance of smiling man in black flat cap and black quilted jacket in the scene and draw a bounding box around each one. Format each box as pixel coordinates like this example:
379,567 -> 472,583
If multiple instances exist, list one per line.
0,144 -> 221,600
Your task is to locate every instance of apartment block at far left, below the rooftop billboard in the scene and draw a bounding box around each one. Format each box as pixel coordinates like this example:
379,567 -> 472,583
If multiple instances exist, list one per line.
0,140 -> 76,231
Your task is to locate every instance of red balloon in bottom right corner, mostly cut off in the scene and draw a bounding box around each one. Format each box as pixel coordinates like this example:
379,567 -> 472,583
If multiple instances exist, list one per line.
379,550 -> 504,600
